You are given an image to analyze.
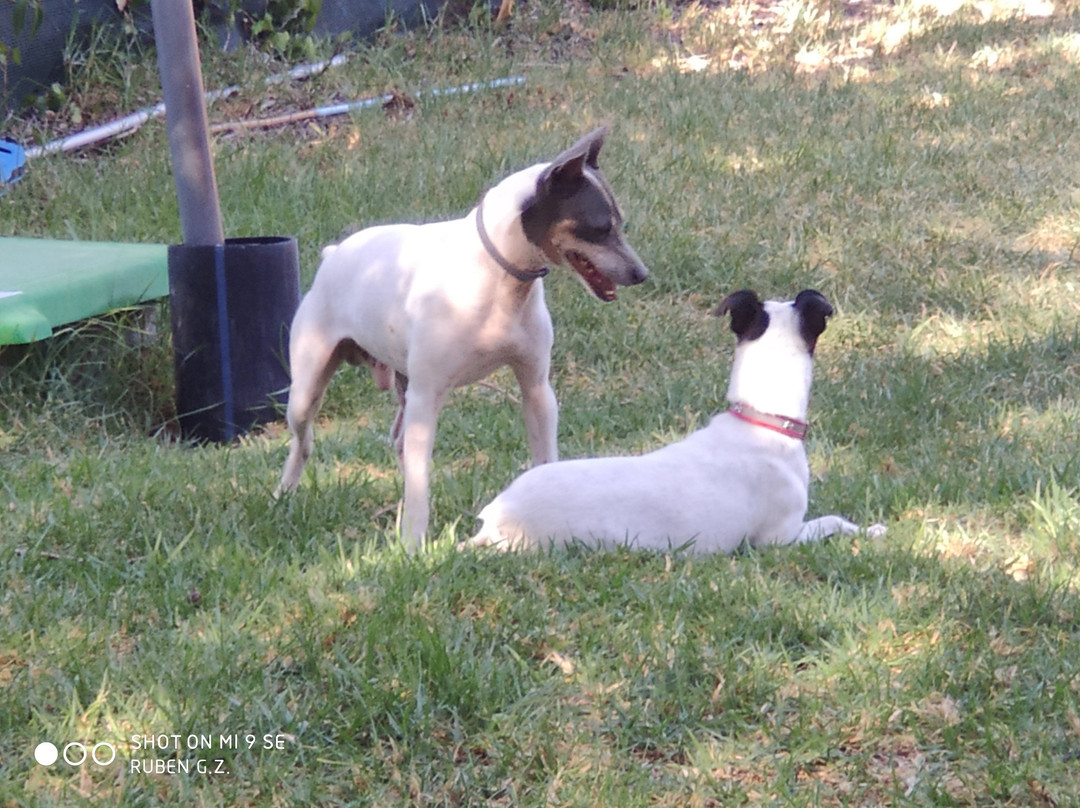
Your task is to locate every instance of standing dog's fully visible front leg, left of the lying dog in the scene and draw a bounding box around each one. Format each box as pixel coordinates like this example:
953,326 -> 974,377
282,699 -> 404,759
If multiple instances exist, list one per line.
401,385 -> 445,553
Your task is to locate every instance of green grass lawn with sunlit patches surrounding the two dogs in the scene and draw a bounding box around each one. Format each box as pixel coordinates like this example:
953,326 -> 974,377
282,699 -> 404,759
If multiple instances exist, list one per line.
0,0 -> 1080,808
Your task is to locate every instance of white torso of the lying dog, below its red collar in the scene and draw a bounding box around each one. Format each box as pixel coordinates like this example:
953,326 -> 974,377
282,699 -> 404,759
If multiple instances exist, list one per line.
474,413 -> 809,553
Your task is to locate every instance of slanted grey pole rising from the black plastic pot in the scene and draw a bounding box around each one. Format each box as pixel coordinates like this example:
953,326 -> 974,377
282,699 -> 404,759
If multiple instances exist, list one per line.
150,0 -> 225,245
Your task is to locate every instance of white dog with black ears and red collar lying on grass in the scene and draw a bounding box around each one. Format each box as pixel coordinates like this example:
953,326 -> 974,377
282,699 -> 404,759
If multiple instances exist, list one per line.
465,289 -> 885,553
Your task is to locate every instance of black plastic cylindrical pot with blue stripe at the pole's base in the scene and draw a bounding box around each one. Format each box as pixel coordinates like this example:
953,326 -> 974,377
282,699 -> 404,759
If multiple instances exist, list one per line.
168,237 -> 300,443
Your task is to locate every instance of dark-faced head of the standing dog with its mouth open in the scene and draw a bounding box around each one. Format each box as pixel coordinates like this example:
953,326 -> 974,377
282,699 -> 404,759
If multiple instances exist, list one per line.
522,126 -> 649,301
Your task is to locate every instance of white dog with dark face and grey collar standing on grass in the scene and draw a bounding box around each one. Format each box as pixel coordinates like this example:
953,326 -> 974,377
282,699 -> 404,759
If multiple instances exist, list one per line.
276,129 -> 648,550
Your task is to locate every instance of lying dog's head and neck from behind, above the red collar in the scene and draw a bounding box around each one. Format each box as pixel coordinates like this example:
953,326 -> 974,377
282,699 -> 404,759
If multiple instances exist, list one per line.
713,289 -> 833,416
